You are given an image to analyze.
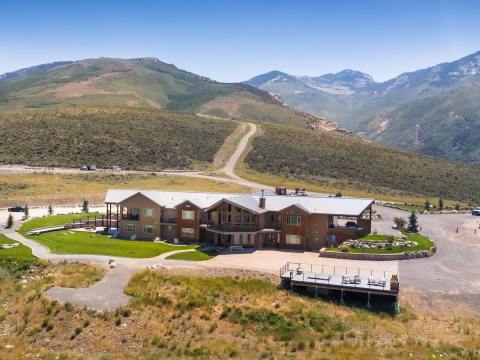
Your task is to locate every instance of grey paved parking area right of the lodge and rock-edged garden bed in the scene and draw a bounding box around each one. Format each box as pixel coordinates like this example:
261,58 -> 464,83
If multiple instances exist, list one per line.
373,207 -> 480,299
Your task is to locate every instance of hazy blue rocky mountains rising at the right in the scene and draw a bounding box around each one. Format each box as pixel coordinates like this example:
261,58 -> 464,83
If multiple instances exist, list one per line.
247,51 -> 480,164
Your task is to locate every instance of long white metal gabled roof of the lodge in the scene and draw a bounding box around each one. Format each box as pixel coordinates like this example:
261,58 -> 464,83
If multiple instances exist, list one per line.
105,189 -> 373,216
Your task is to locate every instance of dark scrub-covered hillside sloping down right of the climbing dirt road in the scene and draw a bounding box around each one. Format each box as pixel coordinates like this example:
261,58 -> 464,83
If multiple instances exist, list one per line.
245,124 -> 480,203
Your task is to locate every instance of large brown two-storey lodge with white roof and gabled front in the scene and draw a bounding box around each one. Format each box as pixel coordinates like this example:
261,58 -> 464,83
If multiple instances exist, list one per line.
105,188 -> 373,250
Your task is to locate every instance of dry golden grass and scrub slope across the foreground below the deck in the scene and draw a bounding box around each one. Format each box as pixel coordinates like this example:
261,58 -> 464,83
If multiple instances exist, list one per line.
0,265 -> 480,360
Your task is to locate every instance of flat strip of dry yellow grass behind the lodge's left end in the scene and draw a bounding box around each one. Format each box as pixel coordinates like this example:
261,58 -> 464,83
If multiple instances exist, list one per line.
0,173 -> 247,206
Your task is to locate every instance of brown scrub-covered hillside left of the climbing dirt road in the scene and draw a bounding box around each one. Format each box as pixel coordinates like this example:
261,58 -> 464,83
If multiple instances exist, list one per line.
0,107 -> 237,170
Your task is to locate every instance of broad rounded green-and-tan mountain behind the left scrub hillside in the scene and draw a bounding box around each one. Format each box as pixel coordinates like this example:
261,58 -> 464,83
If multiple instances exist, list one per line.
0,58 -> 344,129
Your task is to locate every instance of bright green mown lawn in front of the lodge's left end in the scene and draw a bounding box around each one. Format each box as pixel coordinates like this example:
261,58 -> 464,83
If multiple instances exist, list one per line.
25,230 -> 198,258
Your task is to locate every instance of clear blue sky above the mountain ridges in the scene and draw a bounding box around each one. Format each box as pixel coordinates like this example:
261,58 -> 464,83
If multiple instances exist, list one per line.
0,0 -> 480,81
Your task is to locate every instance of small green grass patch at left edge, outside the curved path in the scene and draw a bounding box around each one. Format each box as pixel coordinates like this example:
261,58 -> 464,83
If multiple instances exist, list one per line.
0,234 -> 37,274
